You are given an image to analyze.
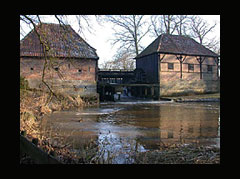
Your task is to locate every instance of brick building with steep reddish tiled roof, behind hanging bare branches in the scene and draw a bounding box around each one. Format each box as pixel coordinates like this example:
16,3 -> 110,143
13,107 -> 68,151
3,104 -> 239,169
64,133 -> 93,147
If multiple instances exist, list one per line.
20,23 -> 99,97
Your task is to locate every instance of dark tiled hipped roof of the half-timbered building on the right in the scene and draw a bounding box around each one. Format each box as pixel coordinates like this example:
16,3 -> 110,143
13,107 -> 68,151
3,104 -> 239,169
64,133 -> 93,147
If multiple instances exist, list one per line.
136,34 -> 219,58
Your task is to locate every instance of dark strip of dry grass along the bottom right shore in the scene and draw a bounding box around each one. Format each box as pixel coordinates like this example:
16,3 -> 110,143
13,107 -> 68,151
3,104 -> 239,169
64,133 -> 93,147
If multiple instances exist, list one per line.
135,144 -> 220,164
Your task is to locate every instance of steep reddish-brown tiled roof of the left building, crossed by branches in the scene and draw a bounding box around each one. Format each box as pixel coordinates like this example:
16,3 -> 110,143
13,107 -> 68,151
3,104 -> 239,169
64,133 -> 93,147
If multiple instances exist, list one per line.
20,23 -> 98,59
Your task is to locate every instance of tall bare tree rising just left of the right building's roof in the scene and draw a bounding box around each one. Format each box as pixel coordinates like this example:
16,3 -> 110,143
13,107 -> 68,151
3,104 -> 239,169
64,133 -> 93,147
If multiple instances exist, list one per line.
105,15 -> 150,55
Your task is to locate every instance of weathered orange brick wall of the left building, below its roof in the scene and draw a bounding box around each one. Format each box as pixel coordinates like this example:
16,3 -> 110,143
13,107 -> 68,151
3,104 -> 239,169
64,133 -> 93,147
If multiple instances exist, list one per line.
20,58 -> 97,96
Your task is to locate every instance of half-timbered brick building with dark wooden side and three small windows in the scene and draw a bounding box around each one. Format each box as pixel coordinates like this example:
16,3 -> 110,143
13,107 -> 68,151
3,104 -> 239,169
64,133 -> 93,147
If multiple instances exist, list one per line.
135,34 -> 220,96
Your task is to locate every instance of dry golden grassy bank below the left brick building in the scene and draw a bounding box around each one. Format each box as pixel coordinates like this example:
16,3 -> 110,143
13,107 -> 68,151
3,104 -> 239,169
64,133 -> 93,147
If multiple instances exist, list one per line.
20,86 -> 97,164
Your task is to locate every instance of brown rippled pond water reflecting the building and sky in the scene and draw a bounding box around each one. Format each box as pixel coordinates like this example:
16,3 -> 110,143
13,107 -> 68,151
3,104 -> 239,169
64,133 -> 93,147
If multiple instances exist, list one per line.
41,101 -> 220,163
